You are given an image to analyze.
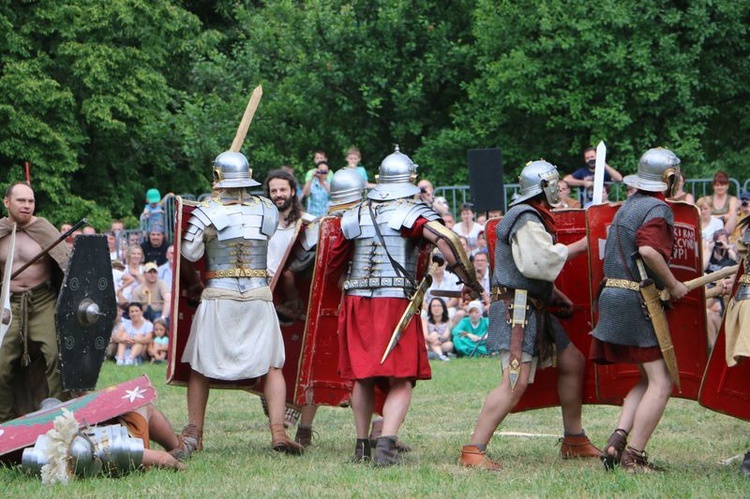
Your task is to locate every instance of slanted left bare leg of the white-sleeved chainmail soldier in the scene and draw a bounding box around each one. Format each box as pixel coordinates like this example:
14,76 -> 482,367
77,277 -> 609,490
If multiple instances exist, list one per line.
471,362 -> 531,447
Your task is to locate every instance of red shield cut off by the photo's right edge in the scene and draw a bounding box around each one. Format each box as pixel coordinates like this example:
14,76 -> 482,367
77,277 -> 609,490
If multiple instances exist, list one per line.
698,264 -> 750,421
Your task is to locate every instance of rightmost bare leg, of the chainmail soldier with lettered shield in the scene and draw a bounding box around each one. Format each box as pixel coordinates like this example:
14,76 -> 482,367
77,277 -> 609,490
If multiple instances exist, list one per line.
630,359 -> 672,450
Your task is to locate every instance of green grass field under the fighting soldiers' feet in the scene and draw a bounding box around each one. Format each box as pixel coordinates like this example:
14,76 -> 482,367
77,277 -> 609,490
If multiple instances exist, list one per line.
0,359 -> 750,498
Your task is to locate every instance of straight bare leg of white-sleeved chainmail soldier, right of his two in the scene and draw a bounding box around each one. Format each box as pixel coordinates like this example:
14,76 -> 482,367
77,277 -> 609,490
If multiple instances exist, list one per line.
557,343 -> 586,435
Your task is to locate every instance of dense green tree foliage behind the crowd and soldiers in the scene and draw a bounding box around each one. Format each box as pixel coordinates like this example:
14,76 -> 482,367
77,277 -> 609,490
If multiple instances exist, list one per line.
0,0 -> 750,227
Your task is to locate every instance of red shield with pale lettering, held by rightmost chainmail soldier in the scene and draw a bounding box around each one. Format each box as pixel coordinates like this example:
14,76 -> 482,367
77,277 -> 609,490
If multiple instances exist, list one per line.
588,202 -> 708,400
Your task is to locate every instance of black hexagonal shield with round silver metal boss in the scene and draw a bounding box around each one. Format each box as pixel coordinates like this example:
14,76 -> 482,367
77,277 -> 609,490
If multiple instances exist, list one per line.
55,235 -> 117,390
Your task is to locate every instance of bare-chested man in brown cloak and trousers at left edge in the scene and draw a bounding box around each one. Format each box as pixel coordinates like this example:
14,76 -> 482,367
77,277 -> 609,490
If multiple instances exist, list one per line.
0,182 -> 70,422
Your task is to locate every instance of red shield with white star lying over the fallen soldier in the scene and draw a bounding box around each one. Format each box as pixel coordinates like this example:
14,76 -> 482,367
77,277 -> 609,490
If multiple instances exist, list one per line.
0,375 -> 156,456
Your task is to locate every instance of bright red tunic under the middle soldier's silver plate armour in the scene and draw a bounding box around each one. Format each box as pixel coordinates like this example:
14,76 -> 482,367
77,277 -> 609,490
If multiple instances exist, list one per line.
329,218 -> 432,380
